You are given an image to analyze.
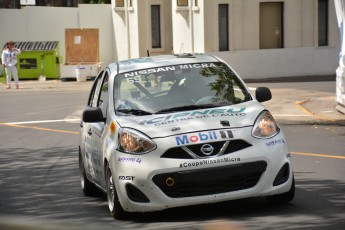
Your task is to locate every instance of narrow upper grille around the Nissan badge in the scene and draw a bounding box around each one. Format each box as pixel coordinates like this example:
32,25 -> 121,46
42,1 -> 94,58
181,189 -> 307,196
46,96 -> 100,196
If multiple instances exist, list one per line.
161,140 -> 252,159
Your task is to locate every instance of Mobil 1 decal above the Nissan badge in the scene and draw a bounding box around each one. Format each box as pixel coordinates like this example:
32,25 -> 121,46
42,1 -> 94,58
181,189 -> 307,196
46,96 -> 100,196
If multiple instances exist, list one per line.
175,130 -> 234,145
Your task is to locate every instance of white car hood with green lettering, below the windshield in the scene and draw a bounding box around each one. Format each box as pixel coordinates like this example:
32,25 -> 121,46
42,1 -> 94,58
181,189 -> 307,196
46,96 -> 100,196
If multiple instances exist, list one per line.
117,101 -> 265,138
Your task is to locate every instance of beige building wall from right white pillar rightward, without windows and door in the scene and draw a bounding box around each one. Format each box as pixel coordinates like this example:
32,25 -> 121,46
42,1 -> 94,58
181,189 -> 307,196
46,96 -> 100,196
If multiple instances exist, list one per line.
173,0 -> 340,78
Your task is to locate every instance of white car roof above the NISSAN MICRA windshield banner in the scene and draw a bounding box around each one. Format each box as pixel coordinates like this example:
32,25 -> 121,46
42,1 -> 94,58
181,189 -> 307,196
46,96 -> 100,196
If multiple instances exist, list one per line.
109,54 -> 219,74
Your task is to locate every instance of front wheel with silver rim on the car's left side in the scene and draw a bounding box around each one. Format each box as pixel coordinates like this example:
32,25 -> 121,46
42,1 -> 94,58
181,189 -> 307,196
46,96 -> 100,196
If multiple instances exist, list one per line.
105,165 -> 129,220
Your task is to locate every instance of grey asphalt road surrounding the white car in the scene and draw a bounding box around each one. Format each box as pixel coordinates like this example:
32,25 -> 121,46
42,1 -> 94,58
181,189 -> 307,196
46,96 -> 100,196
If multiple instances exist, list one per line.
0,82 -> 345,230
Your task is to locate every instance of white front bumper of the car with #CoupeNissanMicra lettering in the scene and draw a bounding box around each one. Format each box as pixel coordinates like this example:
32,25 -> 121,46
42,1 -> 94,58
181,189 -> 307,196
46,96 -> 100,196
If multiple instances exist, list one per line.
109,128 -> 293,212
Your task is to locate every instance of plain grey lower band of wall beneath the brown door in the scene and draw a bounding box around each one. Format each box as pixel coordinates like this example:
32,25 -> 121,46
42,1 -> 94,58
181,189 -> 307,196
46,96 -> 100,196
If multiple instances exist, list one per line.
214,47 -> 339,79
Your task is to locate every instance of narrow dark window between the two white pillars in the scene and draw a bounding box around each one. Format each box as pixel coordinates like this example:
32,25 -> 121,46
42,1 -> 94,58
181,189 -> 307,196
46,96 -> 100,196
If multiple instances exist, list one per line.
151,5 -> 162,48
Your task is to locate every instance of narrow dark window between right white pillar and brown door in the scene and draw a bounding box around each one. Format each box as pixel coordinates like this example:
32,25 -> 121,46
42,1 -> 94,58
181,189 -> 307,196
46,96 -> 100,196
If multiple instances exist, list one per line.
218,4 -> 229,51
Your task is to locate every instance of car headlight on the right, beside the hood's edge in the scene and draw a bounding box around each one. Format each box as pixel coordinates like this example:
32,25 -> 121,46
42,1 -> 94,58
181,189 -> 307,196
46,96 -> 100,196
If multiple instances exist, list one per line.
252,111 -> 280,138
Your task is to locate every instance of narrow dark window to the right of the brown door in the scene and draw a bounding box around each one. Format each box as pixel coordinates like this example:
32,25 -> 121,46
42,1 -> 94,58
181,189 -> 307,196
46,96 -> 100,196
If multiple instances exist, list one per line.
318,0 -> 328,46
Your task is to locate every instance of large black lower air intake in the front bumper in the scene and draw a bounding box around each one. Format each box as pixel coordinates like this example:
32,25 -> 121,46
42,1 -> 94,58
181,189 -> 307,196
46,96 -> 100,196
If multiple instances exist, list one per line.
153,161 -> 267,198
